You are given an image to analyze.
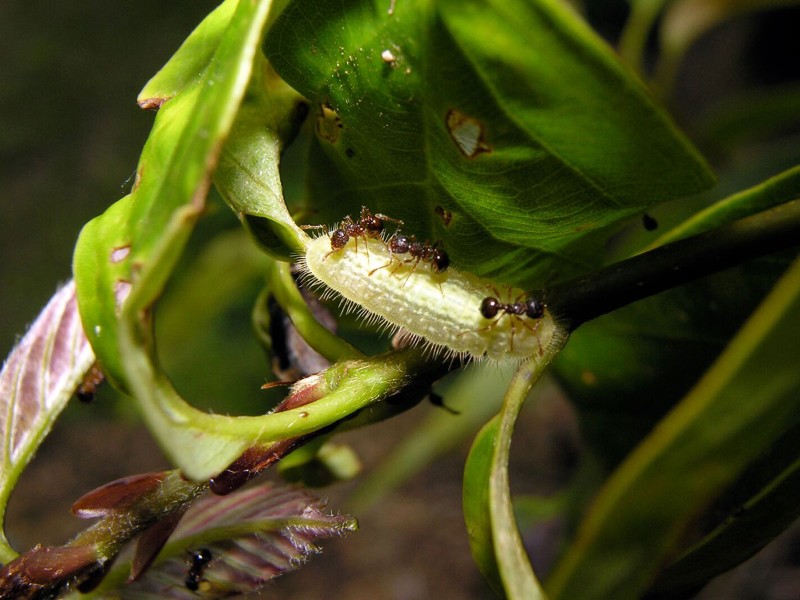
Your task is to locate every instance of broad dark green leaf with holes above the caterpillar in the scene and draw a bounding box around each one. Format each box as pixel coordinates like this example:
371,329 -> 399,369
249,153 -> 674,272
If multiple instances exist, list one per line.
265,0 -> 712,284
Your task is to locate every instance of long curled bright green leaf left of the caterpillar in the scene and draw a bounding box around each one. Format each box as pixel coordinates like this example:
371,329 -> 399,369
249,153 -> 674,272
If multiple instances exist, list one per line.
74,2 -> 282,476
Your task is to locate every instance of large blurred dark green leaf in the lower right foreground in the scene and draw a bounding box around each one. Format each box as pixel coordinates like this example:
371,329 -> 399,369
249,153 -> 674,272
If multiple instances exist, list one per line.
547,261 -> 800,600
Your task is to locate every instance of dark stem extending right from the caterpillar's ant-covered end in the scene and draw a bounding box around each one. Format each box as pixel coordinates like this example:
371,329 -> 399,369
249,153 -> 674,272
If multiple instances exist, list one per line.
548,199 -> 800,331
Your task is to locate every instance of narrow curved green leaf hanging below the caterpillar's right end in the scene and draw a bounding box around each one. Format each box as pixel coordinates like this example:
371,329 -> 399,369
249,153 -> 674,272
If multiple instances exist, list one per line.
463,347 -> 559,600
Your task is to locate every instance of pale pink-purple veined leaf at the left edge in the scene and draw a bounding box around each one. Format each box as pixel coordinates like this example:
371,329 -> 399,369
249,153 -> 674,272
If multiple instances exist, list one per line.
0,281 -> 95,562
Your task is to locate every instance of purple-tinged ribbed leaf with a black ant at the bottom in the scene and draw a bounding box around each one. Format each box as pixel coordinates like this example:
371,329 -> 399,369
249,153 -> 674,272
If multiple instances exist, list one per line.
116,483 -> 356,600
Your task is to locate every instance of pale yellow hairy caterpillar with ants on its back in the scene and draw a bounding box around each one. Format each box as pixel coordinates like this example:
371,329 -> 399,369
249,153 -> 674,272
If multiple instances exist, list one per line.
301,227 -> 566,361
